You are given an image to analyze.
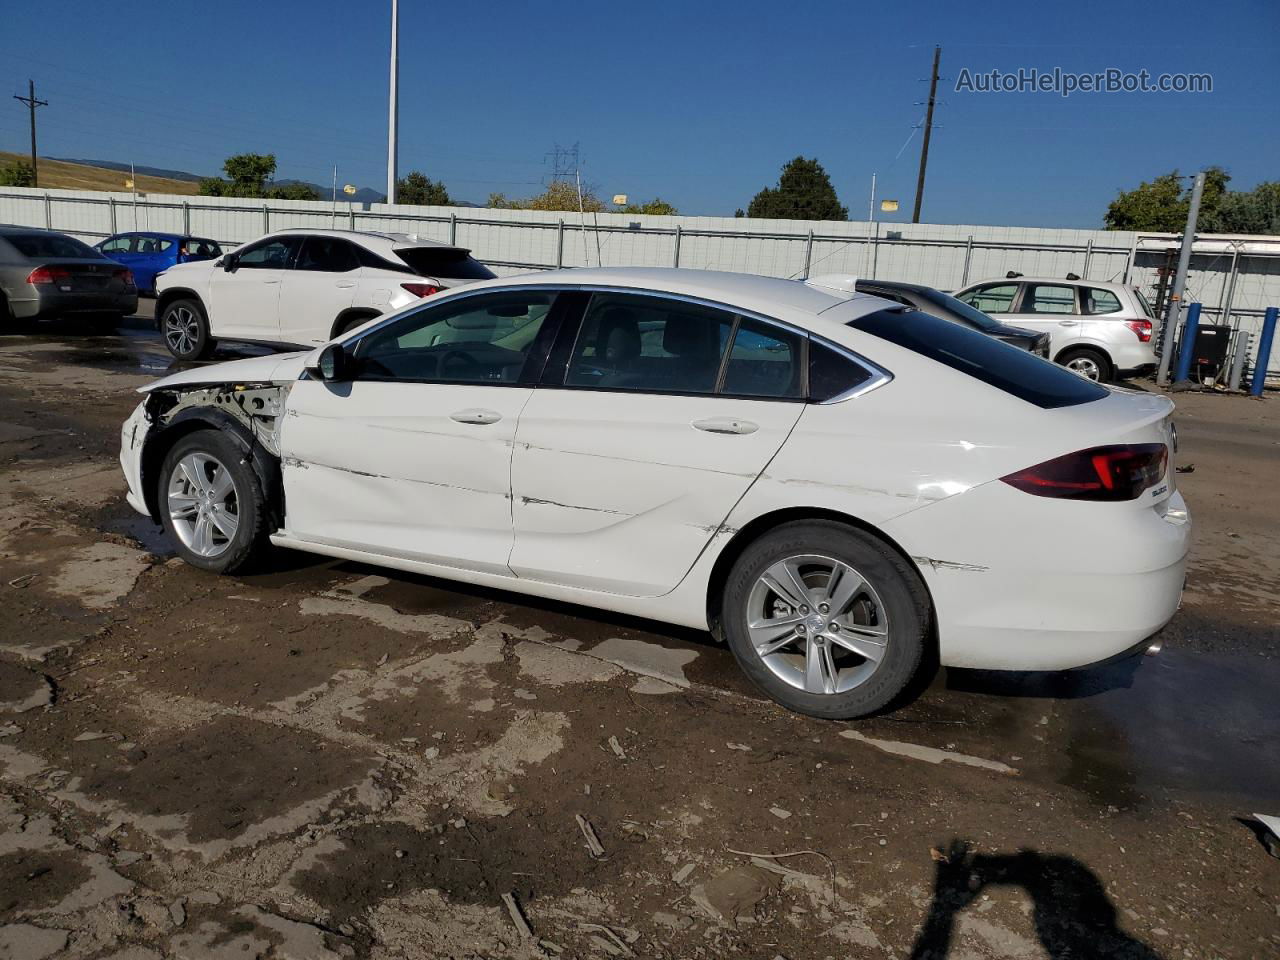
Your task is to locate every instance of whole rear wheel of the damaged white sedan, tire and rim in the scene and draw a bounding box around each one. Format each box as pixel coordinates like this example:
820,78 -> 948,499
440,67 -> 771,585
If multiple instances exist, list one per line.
722,521 -> 929,719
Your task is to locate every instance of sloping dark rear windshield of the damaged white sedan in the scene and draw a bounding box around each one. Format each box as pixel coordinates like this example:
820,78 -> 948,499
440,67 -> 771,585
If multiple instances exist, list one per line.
849,308 -> 1107,410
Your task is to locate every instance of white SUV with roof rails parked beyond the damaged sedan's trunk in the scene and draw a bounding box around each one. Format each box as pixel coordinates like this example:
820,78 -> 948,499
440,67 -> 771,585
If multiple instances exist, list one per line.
955,273 -> 1157,383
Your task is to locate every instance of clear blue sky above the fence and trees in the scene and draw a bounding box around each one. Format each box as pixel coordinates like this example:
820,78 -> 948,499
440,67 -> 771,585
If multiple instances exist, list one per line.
0,0 -> 1280,227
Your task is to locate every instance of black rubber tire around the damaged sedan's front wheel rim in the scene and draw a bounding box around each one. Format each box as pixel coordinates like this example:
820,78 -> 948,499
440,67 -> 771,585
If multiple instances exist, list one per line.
156,430 -> 270,573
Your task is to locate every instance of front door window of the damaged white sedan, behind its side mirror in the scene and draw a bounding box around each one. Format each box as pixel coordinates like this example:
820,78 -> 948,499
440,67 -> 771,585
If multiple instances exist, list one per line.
355,291 -> 556,384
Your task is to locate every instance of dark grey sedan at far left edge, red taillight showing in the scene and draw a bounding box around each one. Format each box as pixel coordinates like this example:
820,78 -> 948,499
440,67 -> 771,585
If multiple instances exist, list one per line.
0,225 -> 138,324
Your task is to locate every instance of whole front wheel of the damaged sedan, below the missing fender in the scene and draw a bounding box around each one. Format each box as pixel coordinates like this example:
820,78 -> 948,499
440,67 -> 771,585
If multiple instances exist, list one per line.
157,430 -> 268,573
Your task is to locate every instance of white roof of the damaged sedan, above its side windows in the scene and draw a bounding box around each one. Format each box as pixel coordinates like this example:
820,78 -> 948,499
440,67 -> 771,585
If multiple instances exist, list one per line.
470,266 -> 901,328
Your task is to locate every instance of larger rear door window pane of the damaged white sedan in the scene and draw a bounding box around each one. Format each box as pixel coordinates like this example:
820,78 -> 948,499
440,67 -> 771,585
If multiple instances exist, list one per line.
564,293 -> 748,393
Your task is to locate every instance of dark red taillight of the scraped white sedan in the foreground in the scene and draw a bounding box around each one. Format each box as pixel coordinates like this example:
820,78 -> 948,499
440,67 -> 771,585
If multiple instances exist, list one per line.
1000,443 -> 1169,500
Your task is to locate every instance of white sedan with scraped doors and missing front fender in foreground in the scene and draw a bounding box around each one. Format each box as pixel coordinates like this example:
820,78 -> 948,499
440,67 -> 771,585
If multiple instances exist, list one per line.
120,269 -> 1190,718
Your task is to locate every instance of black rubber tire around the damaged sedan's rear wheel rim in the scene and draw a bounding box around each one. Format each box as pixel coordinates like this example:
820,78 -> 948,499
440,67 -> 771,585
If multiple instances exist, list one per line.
721,520 -> 931,719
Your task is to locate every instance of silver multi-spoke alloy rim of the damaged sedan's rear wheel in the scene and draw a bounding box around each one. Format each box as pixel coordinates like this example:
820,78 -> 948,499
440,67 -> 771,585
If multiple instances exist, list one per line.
746,556 -> 888,695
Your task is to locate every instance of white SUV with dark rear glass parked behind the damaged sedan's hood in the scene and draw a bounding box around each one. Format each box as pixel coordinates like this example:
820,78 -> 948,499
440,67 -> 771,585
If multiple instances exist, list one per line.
156,229 -> 495,360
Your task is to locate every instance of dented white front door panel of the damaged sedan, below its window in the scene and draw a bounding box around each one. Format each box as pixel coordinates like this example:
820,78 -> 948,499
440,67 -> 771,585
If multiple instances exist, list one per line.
280,380 -> 531,575
